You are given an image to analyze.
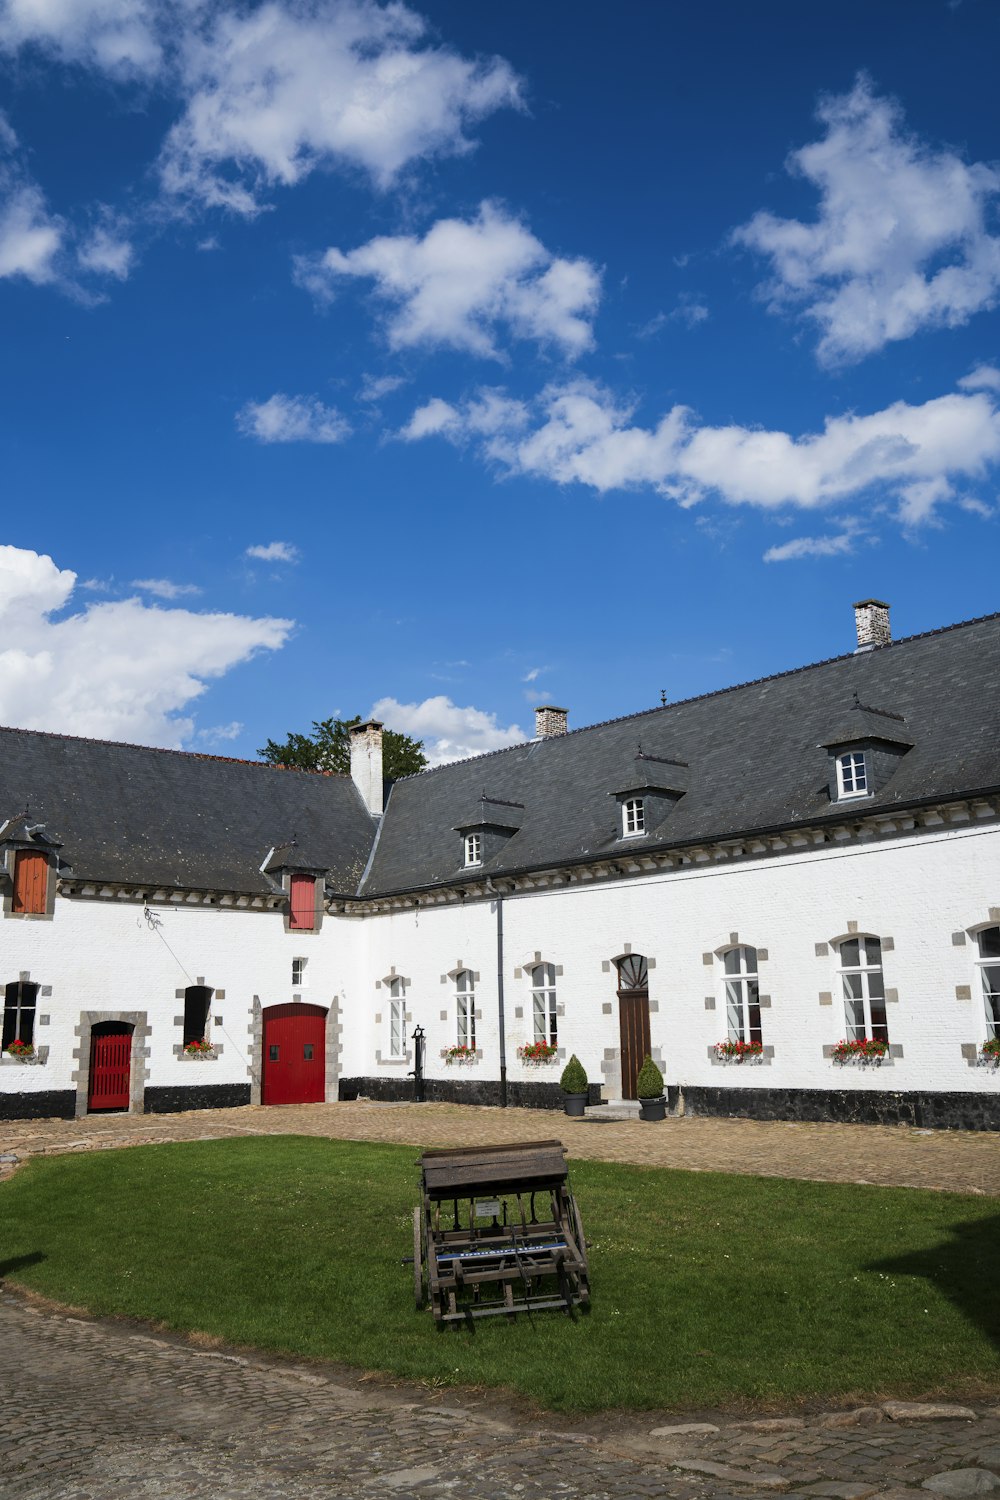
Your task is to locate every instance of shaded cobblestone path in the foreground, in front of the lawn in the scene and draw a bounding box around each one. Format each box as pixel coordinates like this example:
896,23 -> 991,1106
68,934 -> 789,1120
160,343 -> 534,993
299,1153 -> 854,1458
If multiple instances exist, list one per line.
0,1295 -> 1000,1500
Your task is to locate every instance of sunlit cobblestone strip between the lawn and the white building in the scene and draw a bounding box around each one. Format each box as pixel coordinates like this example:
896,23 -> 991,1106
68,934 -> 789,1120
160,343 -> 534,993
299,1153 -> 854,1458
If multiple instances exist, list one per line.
0,1100 -> 1000,1196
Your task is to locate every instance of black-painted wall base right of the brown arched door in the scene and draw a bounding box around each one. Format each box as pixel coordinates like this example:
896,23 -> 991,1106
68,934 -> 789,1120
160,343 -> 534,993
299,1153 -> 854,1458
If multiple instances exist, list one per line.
684,1088 -> 1000,1130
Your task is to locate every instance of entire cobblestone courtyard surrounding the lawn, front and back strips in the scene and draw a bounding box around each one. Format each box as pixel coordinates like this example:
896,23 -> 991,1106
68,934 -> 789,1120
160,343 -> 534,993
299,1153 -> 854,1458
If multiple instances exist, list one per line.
0,1101 -> 1000,1500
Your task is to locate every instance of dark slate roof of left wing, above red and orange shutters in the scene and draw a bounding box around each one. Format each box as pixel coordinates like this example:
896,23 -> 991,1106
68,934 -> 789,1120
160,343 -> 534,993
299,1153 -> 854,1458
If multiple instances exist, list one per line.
0,729 -> 375,894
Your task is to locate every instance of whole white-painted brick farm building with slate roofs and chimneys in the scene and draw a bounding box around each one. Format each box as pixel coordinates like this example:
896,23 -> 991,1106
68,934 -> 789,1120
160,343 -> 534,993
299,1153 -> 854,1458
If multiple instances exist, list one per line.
0,600 -> 1000,1130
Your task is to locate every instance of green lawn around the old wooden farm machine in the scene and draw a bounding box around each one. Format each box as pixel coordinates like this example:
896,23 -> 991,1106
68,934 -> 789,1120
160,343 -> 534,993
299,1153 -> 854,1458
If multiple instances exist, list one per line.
0,1137 -> 1000,1410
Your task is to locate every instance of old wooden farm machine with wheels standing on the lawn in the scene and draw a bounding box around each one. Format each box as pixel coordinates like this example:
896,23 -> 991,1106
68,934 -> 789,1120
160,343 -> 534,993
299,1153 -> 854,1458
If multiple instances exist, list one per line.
414,1140 -> 591,1323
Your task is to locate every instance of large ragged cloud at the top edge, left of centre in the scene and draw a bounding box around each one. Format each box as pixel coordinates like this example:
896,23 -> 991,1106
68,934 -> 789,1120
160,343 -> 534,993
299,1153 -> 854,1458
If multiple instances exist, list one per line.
160,0 -> 520,215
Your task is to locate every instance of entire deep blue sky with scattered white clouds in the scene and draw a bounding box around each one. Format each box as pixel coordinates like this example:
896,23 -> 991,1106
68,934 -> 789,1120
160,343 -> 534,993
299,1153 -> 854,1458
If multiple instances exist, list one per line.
0,0 -> 1000,759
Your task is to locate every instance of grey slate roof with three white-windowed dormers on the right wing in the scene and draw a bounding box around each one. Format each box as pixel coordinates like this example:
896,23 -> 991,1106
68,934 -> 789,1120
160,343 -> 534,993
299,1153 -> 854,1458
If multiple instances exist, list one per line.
361,615 -> 1000,896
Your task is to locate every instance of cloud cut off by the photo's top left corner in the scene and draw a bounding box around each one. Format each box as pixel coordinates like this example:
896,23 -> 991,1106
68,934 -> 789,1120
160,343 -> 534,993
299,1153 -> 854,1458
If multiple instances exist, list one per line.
0,0 -> 162,75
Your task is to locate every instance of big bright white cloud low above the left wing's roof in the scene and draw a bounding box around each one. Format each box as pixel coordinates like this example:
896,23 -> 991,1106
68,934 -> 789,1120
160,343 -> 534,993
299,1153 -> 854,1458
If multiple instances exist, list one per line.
0,546 -> 292,749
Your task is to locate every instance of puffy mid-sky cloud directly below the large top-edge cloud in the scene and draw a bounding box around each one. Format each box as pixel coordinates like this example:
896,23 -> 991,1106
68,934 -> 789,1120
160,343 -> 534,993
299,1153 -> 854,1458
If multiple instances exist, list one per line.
297,203 -> 600,357
